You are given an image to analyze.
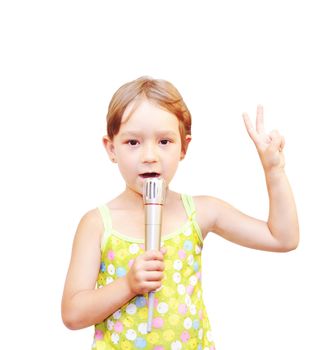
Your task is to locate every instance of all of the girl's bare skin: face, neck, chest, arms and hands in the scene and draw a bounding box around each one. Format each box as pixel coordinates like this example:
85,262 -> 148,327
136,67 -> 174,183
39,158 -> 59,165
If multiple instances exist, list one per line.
62,99 -> 299,329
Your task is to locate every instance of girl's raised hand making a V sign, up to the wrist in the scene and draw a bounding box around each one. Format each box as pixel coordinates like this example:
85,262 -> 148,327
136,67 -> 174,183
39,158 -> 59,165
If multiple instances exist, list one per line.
242,105 -> 285,172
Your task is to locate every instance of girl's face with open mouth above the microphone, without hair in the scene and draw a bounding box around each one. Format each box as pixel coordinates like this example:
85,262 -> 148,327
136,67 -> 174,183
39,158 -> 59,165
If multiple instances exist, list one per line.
104,99 -> 184,193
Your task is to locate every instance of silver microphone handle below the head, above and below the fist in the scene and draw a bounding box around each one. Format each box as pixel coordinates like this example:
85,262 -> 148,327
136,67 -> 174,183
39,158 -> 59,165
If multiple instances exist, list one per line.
145,204 -> 162,333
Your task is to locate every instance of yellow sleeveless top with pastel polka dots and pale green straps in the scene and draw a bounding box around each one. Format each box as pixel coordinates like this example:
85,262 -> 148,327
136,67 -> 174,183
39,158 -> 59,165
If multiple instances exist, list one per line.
92,195 -> 215,350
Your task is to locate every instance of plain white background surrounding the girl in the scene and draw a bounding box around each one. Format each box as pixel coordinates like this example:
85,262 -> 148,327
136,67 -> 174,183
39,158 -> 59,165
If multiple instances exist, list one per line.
0,0 -> 326,350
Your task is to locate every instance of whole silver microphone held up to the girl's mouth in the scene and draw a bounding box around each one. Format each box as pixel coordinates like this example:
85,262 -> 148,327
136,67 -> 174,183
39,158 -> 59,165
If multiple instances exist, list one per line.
143,177 -> 166,333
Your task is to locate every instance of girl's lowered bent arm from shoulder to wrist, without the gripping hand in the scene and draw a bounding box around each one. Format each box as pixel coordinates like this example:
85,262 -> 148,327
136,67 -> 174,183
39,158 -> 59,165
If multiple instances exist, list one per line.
62,211 -> 133,329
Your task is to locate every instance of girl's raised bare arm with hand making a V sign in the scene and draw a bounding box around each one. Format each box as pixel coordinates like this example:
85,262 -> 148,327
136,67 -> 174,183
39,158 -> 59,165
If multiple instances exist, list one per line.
197,106 -> 299,251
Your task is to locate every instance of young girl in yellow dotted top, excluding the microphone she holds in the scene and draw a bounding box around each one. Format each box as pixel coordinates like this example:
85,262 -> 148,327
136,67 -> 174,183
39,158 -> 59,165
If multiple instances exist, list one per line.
62,77 -> 299,350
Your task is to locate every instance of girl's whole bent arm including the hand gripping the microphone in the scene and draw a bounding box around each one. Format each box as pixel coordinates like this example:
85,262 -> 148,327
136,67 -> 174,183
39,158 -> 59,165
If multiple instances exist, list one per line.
62,210 -> 164,329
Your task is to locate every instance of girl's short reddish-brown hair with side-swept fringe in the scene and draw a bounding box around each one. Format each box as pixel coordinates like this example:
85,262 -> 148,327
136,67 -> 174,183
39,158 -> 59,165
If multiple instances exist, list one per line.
106,76 -> 191,152
